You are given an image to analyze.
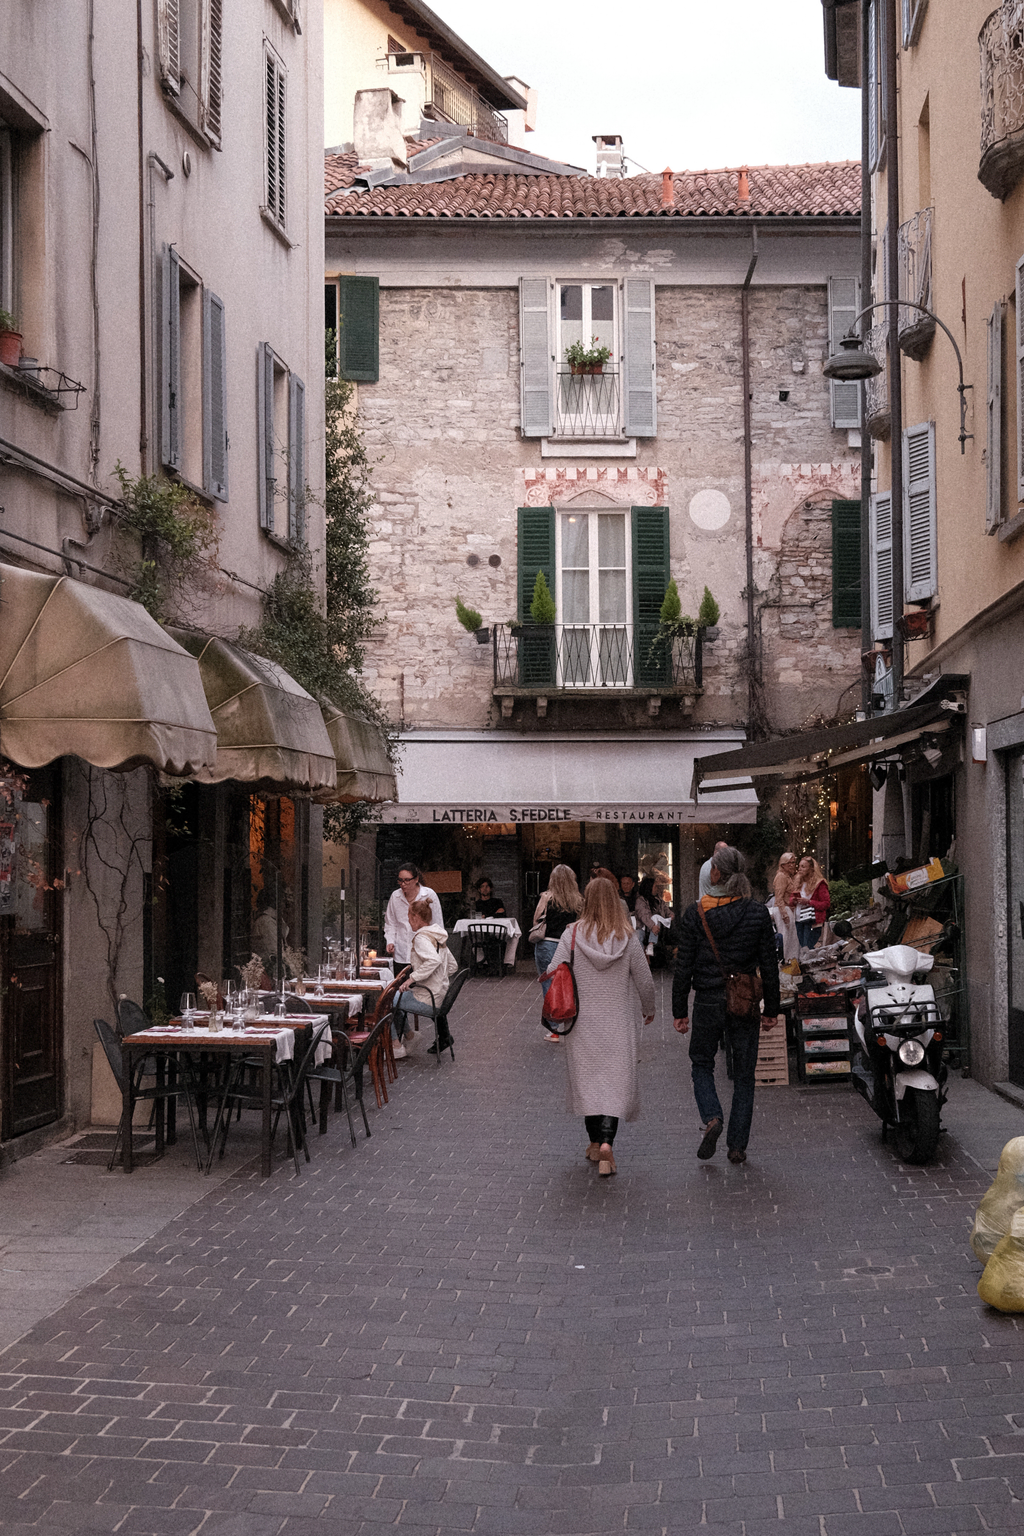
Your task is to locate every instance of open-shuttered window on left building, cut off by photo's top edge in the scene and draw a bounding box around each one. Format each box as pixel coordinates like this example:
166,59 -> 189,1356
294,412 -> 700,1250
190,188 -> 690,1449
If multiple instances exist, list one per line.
157,0 -> 224,149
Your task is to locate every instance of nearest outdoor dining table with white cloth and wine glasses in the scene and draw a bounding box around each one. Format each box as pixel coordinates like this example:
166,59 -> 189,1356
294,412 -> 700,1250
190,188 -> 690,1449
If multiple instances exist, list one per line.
121,1014 -> 332,1178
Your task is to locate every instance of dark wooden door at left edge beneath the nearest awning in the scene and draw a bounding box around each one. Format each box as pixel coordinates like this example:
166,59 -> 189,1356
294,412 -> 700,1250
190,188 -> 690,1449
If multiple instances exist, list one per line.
0,766 -> 64,1140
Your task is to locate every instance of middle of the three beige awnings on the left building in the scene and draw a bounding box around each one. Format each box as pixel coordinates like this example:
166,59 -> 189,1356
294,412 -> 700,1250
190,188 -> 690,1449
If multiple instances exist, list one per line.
170,630 -> 338,793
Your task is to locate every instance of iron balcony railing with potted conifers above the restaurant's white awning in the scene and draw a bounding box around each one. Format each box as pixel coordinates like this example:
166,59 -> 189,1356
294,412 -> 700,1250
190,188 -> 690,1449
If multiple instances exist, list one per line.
493,624 -> 703,693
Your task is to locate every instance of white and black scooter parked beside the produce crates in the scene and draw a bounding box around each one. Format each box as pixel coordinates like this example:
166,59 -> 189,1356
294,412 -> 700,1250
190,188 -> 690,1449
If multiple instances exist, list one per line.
852,945 -> 947,1163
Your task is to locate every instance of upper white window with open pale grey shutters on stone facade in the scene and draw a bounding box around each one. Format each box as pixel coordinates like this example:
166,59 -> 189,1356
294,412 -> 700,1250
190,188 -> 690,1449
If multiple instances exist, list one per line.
519,278 -> 657,439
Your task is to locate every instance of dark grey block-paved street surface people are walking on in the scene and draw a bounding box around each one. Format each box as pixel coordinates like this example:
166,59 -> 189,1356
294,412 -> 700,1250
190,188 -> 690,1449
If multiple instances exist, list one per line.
0,977 -> 1024,1536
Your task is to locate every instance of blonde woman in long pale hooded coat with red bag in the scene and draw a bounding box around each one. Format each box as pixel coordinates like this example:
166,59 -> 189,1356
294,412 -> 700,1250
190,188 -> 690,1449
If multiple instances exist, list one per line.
550,879 -> 654,1175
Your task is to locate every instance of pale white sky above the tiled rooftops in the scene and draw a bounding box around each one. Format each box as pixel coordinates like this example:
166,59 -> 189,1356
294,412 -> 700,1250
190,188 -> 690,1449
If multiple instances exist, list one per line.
431,0 -> 860,174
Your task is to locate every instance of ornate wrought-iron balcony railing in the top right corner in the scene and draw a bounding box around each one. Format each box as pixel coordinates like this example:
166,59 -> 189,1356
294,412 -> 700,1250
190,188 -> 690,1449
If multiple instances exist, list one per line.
978,0 -> 1024,200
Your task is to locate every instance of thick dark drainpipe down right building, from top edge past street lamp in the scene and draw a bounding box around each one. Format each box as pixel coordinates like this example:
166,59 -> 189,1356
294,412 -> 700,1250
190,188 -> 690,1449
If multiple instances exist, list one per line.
881,0 -> 903,710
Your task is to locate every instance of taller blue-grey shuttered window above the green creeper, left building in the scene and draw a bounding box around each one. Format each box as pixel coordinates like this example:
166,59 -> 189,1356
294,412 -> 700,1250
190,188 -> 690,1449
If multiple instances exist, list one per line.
160,246 -> 227,501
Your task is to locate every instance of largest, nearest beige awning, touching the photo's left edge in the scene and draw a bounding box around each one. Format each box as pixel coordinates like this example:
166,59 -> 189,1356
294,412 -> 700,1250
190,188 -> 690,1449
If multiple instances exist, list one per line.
0,565 -> 216,774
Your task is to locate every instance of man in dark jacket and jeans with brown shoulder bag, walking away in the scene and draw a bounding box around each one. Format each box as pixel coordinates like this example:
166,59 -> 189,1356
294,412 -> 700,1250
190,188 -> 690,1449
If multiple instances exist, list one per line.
672,848 -> 780,1163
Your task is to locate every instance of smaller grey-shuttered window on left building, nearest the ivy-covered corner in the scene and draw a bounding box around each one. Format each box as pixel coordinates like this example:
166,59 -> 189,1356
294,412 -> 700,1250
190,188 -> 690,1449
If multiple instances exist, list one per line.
256,341 -> 306,544
